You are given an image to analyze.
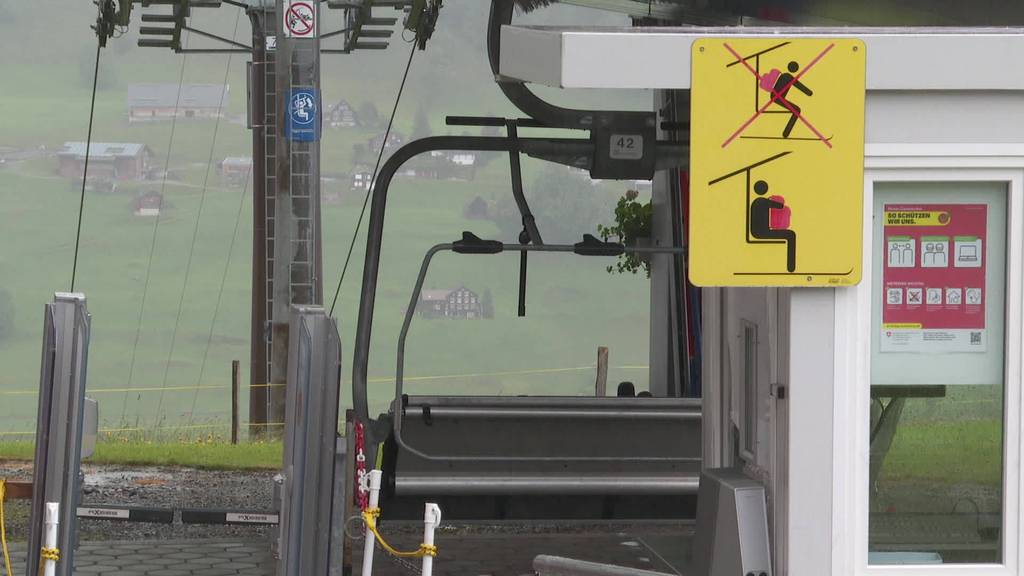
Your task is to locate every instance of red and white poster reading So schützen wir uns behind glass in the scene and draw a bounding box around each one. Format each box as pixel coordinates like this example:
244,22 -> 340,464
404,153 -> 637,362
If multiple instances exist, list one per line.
881,204 -> 987,354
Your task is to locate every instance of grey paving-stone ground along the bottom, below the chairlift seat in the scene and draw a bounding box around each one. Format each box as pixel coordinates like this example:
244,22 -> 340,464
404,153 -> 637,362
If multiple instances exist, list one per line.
0,528 -> 691,576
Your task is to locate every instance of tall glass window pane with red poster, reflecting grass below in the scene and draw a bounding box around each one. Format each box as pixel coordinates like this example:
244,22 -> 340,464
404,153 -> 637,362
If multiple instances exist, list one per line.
868,182 -> 1008,565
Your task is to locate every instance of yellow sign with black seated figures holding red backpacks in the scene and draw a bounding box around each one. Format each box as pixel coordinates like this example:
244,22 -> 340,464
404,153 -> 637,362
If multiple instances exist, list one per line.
689,38 -> 865,286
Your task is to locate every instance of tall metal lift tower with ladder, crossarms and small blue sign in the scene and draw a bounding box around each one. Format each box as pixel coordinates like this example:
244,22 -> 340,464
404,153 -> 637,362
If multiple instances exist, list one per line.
95,0 -> 413,435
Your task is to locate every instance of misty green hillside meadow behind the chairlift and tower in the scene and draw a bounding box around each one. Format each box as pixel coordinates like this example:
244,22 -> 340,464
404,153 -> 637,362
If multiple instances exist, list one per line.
0,0 -> 650,441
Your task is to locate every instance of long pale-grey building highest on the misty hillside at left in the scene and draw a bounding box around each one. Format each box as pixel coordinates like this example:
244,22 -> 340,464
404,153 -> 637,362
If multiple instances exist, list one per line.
128,84 -> 229,122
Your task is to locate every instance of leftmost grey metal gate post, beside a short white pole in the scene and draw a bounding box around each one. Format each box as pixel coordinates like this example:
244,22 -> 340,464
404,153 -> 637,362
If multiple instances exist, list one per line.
26,292 -> 90,576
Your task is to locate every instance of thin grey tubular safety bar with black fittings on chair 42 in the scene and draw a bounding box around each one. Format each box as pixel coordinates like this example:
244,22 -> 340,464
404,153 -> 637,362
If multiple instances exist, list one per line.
391,240 -> 698,462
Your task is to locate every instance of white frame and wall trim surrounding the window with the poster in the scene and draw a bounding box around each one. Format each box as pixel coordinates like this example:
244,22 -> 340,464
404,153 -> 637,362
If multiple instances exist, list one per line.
833,143 -> 1024,576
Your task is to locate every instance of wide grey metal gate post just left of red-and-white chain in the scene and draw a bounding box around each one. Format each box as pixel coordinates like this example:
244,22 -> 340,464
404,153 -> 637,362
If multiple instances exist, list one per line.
278,305 -> 341,576
